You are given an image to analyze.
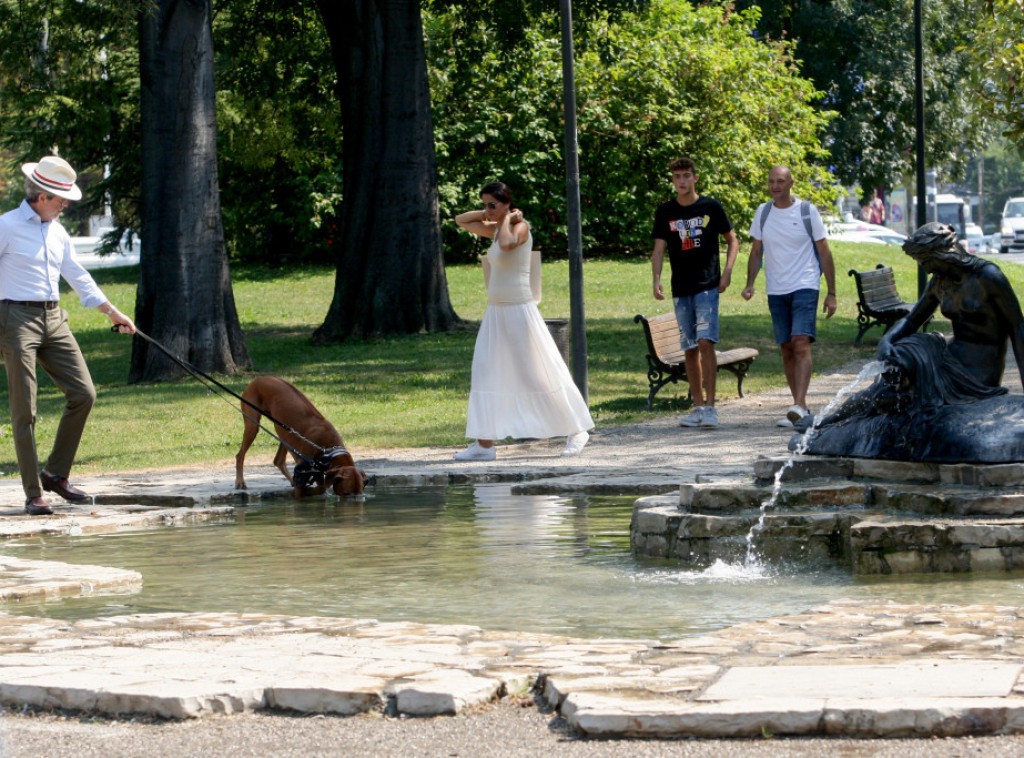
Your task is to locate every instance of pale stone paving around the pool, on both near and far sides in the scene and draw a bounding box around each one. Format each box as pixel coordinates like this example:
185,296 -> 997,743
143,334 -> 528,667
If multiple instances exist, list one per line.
0,367 -> 1024,736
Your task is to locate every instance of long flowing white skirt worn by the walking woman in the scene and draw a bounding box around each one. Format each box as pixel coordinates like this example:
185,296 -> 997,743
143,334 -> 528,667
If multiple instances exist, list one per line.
466,302 -> 594,439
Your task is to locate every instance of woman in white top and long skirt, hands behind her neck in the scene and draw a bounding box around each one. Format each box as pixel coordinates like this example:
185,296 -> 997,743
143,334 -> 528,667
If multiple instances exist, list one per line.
455,181 -> 594,461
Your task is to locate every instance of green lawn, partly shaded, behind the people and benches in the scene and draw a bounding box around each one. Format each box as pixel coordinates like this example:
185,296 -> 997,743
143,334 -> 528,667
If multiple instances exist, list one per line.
0,243 -> 999,476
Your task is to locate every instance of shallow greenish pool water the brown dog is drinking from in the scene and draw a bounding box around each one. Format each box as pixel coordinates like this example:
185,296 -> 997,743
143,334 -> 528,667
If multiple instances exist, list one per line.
3,485 -> 1024,639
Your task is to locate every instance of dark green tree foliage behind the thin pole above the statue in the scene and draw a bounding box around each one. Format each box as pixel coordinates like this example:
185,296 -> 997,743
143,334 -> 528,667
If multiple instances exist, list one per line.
738,0 -> 988,197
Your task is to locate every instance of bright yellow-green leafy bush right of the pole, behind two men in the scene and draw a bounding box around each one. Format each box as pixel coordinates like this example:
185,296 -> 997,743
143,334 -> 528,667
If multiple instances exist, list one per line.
578,0 -> 831,250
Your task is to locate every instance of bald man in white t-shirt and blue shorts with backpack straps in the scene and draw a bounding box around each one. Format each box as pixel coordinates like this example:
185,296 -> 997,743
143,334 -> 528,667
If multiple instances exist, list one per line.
742,166 -> 836,431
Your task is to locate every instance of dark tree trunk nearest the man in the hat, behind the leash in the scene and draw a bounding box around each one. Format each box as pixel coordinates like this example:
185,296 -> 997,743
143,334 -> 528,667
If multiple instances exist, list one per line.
128,0 -> 252,382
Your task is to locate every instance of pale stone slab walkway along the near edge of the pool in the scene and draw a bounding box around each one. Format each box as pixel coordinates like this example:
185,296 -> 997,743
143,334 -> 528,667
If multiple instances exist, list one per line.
0,601 -> 1024,738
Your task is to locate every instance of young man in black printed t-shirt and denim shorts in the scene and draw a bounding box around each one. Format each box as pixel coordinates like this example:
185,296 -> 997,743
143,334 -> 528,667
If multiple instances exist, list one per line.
650,158 -> 739,426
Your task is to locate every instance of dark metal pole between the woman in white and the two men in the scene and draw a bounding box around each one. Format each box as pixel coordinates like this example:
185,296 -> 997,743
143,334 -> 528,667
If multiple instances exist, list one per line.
561,0 -> 590,402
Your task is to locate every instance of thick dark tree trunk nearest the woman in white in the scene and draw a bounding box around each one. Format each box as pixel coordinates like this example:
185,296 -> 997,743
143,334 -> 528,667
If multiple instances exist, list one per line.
313,0 -> 460,343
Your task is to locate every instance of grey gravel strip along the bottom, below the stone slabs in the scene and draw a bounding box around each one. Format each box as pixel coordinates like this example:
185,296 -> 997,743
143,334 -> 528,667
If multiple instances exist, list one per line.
0,699 -> 1011,758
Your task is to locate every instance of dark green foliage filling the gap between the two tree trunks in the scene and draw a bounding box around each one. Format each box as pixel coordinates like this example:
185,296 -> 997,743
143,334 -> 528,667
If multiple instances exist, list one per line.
214,0 -> 341,265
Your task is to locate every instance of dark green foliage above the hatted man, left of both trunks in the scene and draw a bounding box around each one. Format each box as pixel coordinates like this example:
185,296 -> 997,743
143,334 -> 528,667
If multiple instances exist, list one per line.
0,0 -> 147,234
